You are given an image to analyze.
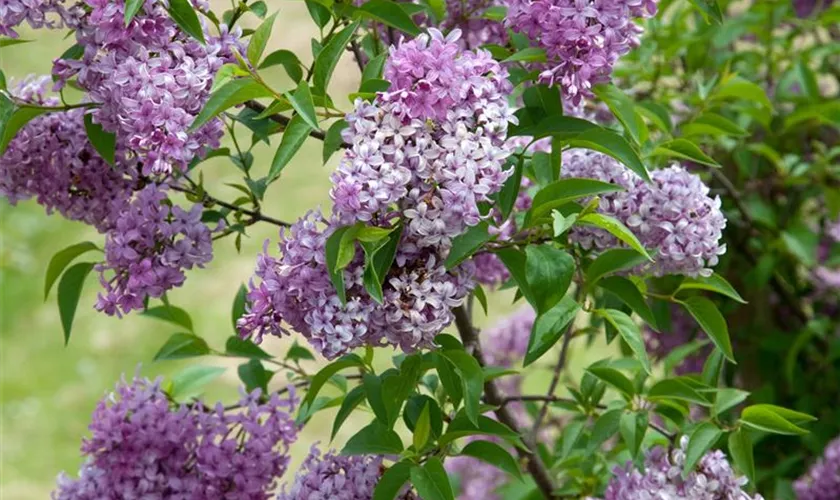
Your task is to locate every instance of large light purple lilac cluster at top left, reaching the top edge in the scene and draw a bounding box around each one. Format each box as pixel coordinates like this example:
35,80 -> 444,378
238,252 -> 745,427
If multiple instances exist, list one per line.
53,0 -> 242,175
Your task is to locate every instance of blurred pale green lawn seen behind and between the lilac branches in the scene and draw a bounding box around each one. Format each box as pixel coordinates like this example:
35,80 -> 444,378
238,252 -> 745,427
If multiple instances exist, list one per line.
0,2 -> 605,500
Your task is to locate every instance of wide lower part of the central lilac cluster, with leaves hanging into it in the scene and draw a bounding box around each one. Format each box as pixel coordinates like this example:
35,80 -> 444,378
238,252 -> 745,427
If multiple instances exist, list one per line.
237,212 -> 472,359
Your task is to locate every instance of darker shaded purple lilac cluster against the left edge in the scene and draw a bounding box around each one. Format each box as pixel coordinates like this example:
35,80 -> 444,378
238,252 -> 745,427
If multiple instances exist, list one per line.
0,77 -> 134,231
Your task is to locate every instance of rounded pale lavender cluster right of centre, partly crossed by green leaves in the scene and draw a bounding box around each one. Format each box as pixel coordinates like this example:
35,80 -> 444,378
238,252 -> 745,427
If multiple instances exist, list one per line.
562,149 -> 726,276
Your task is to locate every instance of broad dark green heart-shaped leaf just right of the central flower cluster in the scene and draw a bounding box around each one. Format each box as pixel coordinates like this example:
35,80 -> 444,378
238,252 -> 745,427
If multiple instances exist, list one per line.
525,243 -> 575,314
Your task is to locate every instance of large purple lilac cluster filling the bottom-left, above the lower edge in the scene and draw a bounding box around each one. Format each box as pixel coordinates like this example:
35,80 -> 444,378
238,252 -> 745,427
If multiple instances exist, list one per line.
52,378 -> 298,500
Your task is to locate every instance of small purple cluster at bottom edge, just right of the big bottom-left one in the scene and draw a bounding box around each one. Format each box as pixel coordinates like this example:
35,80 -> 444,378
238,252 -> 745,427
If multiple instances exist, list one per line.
277,446 -> 417,500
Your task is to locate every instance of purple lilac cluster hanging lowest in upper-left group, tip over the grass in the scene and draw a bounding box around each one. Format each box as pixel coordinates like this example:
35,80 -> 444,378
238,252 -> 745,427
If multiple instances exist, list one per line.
96,184 -> 213,315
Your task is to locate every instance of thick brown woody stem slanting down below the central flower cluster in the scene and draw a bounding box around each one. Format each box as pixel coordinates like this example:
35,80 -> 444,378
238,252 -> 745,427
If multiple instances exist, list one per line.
452,306 -> 560,498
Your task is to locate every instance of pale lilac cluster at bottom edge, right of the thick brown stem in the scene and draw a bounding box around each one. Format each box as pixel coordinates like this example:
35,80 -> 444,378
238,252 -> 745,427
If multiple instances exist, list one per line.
604,436 -> 763,500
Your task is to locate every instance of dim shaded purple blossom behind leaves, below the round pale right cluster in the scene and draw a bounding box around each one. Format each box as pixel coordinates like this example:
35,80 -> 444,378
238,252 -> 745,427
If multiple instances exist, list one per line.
642,306 -> 712,375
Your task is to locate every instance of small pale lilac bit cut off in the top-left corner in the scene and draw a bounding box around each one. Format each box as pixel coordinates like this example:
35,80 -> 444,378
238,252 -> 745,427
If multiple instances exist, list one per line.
0,0 -> 84,38
